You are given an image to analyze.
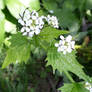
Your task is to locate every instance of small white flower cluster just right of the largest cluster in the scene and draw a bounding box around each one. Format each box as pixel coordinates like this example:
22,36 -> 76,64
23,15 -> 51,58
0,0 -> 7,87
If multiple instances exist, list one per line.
46,15 -> 59,28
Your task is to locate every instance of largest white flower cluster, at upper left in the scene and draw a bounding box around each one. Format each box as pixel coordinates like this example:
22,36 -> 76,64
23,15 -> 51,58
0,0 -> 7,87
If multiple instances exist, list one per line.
18,9 -> 44,37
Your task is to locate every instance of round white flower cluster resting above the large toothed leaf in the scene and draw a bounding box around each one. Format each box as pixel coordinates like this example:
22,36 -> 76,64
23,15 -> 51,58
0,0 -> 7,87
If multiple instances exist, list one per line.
55,35 -> 75,54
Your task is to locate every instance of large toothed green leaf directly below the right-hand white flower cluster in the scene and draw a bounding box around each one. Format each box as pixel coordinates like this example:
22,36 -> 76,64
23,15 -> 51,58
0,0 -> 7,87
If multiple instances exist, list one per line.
46,47 -> 88,81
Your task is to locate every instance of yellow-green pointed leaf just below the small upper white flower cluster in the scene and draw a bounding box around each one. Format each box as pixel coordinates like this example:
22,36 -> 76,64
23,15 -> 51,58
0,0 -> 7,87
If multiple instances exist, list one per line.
39,27 -> 69,42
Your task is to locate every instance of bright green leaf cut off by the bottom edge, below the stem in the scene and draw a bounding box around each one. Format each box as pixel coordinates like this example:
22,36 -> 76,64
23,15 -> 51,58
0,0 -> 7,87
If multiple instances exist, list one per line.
59,83 -> 89,92
